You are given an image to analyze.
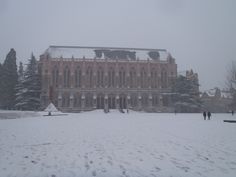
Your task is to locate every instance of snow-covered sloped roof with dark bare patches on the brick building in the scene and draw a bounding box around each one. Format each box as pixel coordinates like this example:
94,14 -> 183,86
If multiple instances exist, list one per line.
45,45 -> 170,60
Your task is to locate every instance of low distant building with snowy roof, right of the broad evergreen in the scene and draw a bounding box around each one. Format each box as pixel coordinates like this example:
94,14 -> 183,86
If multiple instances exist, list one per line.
201,87 -> 232,112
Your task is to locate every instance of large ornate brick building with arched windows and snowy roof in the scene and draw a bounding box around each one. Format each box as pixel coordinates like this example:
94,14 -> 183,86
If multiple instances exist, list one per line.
39,46 -> 177,111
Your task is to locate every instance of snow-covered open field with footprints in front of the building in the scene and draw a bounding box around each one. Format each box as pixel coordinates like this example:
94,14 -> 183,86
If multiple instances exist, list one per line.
0,111 -> 236,177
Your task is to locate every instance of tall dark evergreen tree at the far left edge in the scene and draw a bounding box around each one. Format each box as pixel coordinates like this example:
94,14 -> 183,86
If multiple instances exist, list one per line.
1,49 -> 18,109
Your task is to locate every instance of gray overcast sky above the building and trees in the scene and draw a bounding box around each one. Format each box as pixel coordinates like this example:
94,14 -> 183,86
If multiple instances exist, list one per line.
0,0 -> 236,90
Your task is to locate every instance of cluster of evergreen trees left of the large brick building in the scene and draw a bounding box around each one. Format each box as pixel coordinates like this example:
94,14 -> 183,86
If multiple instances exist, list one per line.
0,49 -> 41,110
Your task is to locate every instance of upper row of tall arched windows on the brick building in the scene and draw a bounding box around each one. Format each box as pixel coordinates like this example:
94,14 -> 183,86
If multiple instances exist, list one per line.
52,67 -> 170,88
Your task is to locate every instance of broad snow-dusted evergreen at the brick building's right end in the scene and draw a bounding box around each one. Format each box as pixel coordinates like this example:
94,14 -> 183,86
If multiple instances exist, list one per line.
172,75 -> 201,112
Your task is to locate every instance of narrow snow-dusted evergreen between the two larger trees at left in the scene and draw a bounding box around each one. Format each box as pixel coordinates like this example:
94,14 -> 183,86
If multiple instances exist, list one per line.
15,62 -> 26,110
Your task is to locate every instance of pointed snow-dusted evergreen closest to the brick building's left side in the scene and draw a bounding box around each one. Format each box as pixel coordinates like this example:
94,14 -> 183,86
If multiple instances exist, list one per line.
21,54 -> 41,110
